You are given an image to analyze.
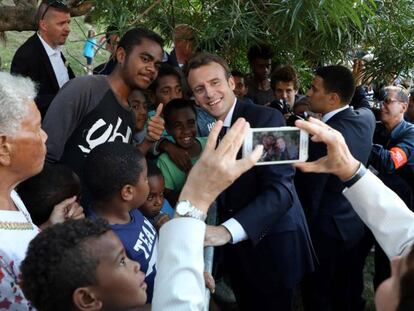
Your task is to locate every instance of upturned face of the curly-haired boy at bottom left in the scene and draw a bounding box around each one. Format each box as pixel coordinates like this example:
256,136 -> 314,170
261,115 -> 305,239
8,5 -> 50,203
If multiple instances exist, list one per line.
90,231 -> 147,310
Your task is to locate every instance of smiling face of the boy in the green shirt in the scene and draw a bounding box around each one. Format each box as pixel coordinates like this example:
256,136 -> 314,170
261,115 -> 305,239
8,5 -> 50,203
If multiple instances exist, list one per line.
168,108 -> 197,149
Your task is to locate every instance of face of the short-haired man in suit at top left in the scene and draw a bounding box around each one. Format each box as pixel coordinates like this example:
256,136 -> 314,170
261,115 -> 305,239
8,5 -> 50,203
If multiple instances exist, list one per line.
39,7 -> 70,48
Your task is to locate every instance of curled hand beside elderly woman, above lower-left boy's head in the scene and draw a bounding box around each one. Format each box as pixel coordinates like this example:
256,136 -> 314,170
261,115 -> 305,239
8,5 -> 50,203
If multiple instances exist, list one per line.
40,196 -> 85,229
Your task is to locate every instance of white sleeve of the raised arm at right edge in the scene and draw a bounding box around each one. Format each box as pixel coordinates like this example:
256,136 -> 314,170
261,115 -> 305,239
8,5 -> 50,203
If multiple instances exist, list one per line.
343,170 -> 414,258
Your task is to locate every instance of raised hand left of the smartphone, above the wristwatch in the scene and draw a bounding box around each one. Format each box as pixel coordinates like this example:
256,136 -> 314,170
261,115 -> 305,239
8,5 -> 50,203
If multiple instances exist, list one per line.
179,118 -> 263,213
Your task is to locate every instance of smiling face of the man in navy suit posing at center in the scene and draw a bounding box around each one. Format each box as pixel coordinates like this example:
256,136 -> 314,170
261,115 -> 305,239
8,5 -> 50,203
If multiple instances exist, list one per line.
188,62 -> 236,120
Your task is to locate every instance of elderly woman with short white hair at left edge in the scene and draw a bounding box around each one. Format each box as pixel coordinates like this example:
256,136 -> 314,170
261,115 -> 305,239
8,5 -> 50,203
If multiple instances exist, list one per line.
0,72 -> 79,310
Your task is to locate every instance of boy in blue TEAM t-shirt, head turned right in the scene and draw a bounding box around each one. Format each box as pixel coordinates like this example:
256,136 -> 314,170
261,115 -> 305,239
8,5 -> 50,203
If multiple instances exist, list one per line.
84,142 -> 157,302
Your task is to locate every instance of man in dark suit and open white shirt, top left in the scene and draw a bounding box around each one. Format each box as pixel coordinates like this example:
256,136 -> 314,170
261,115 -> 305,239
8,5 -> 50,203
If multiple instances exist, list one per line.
10,0 -> 75,118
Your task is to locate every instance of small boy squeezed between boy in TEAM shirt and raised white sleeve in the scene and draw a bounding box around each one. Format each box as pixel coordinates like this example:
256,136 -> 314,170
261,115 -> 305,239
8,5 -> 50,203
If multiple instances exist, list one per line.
139,163 -> 174,230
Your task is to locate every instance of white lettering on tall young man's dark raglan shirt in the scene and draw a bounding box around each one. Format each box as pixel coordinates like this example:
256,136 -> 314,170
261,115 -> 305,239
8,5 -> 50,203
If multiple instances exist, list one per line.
78,117 -> 132,153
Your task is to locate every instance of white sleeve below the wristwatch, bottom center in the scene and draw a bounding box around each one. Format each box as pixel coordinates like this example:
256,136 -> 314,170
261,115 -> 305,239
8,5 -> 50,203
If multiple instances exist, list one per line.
152,217 -> 206,311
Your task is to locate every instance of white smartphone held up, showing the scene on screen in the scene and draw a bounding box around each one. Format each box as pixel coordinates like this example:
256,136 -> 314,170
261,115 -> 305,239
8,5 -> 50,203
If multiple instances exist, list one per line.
243,126 -> 309,165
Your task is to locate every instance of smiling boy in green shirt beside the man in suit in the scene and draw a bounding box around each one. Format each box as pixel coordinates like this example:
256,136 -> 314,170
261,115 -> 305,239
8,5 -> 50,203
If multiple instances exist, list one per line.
157,99 -> 206,205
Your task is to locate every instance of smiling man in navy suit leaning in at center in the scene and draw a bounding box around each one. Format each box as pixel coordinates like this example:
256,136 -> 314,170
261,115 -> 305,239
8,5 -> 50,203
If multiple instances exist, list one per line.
185,53 -> 313,310
